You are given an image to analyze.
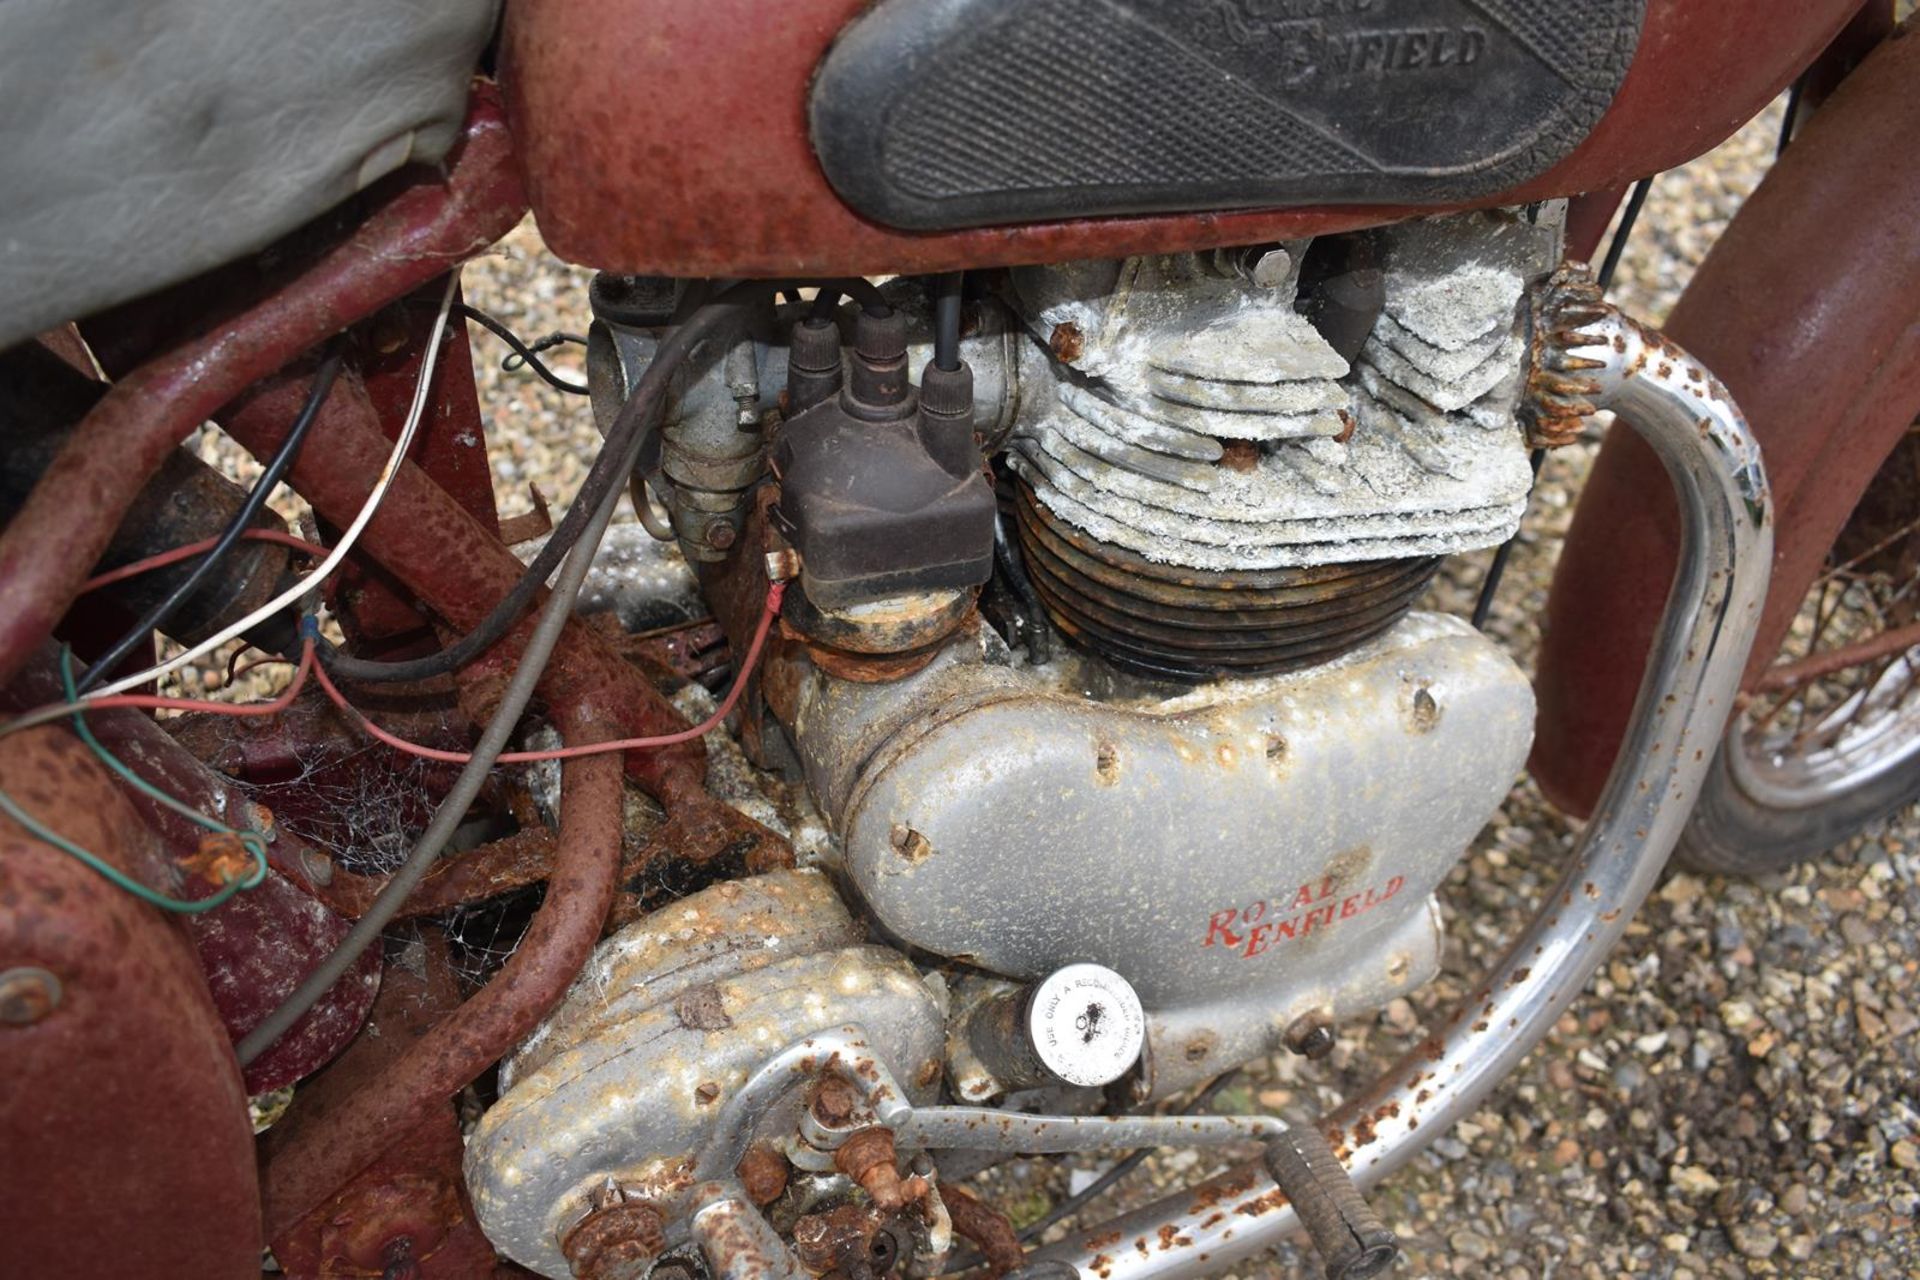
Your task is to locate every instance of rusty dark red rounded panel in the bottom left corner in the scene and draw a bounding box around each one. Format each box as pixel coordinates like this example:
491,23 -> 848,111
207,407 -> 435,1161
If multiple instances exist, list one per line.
0,725 -> 261,1280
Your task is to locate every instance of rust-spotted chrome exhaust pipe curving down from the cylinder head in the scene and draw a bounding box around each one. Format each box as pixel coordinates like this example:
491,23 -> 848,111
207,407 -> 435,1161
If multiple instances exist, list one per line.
1037,269 -> 1774,1280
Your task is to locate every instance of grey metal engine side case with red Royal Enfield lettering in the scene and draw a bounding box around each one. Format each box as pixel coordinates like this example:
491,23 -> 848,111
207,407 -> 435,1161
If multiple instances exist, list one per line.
793,614 -> 1534,1096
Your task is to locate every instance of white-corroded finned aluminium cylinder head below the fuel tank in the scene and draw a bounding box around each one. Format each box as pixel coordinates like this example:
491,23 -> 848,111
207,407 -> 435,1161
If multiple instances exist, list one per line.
1012,207 -> 1561,572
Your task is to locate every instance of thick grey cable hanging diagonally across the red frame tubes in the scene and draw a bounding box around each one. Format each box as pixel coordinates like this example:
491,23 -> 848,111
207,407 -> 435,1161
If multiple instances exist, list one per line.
234,454 -> 620,1067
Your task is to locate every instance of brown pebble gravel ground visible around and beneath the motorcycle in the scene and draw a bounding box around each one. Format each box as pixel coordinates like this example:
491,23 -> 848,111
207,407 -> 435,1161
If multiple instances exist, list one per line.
412,92 -> 1920,1280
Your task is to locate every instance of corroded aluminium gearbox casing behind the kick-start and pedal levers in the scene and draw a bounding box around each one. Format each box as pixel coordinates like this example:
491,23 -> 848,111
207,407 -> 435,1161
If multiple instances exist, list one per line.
467,871 -> 945,1276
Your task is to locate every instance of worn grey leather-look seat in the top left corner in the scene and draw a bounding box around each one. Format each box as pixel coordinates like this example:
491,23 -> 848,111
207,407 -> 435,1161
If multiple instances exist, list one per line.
0,0 -> 497,347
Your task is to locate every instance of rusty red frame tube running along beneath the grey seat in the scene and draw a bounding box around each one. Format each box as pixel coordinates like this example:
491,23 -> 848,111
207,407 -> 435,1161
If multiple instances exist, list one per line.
0,94 -> 526,685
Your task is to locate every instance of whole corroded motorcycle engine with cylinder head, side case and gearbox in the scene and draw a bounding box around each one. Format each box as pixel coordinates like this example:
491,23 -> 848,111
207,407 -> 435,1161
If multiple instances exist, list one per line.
467,205 -> 1561,1276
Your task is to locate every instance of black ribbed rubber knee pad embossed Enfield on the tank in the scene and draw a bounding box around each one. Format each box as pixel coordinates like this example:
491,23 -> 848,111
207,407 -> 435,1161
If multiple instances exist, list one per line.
810,0 -> 1645,230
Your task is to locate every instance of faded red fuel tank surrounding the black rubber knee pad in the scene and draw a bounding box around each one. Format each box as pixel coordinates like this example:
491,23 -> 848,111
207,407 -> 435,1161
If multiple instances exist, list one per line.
501,0 -> 1859,276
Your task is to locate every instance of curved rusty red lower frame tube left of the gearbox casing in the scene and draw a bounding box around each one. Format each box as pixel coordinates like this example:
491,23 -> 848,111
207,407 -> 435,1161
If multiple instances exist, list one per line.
263,704 -> 622,1240
